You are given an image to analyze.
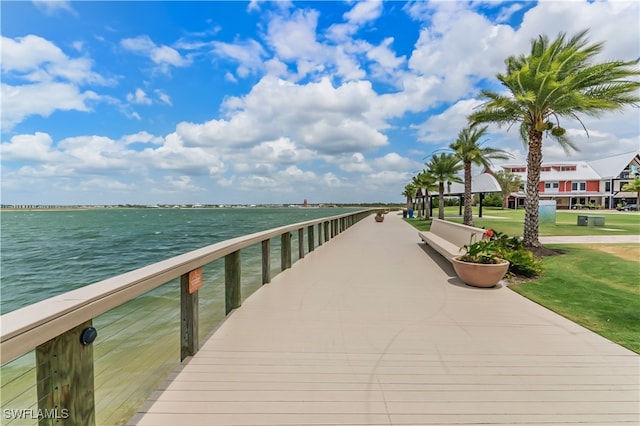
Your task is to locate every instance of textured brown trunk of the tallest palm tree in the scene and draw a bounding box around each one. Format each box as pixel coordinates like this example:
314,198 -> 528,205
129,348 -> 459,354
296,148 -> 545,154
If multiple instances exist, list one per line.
523,126 -> 542,247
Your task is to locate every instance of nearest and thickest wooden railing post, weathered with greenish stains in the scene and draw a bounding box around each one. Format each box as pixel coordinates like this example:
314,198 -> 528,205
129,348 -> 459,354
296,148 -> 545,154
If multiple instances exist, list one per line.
36,320 -> 96,426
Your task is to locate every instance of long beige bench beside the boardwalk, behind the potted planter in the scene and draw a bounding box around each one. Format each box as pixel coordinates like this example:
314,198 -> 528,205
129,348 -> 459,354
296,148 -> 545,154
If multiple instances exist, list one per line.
418,219 -> 486,262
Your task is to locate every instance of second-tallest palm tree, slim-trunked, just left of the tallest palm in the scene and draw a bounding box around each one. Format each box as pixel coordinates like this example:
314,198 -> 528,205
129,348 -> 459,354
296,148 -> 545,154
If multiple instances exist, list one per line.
449,126 -> 511,226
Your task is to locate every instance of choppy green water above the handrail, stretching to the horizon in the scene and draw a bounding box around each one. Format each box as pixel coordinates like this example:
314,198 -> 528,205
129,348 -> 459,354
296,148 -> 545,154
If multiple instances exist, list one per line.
0,208 -> 352,313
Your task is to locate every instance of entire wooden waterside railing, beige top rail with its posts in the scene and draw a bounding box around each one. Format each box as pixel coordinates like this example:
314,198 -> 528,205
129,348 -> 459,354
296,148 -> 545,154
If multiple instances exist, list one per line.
0,210 -> 373,425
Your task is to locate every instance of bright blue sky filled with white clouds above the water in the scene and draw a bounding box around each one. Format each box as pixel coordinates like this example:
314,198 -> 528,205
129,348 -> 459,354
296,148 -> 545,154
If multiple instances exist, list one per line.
0,1 -> 640,204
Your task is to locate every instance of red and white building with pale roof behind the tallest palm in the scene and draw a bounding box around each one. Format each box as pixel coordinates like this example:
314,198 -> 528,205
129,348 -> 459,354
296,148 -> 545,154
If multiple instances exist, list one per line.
501,151 -> 640,209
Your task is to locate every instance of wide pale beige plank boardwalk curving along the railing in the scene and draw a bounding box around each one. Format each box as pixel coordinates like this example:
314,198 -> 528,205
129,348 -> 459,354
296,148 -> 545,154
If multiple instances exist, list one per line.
130,215 -> 640,426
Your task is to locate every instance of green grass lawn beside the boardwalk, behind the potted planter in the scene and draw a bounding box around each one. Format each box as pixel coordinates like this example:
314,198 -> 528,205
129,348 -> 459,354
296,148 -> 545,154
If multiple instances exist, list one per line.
406,207 -> 640,353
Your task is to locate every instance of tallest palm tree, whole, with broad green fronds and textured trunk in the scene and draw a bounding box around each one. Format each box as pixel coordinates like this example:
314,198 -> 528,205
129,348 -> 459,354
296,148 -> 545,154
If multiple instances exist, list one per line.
469,31 -> 640,247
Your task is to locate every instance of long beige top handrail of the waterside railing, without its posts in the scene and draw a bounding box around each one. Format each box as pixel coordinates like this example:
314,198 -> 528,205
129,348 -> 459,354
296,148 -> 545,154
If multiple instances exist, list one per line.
0,209 -> 374,365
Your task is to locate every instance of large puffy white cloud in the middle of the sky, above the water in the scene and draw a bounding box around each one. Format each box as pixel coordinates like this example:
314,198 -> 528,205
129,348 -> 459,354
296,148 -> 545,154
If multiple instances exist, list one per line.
177,76 -> 388,154
